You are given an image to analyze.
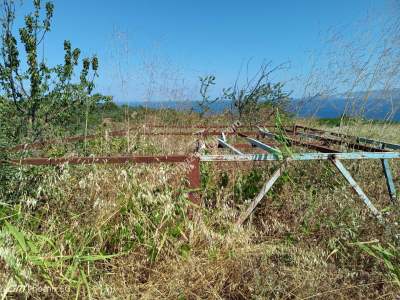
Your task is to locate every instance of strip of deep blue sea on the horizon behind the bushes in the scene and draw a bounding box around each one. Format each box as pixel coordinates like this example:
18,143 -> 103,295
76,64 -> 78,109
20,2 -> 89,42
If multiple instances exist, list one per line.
119,98 -> 400,122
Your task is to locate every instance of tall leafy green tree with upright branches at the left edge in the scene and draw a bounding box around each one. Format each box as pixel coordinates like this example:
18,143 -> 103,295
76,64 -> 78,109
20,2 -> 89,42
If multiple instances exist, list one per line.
0,0 -> 108,140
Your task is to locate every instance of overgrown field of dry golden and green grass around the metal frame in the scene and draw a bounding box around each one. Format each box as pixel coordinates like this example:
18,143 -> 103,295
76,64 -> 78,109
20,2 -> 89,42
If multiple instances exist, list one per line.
0,112 -> 400,299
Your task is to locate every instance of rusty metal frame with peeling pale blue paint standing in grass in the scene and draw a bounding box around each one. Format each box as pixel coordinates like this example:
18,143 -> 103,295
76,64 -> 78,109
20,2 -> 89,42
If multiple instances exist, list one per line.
2,125 -> 400,224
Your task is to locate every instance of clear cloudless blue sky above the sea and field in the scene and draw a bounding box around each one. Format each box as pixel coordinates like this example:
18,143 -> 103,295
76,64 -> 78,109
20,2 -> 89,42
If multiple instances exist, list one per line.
14,0 -> 391,101
